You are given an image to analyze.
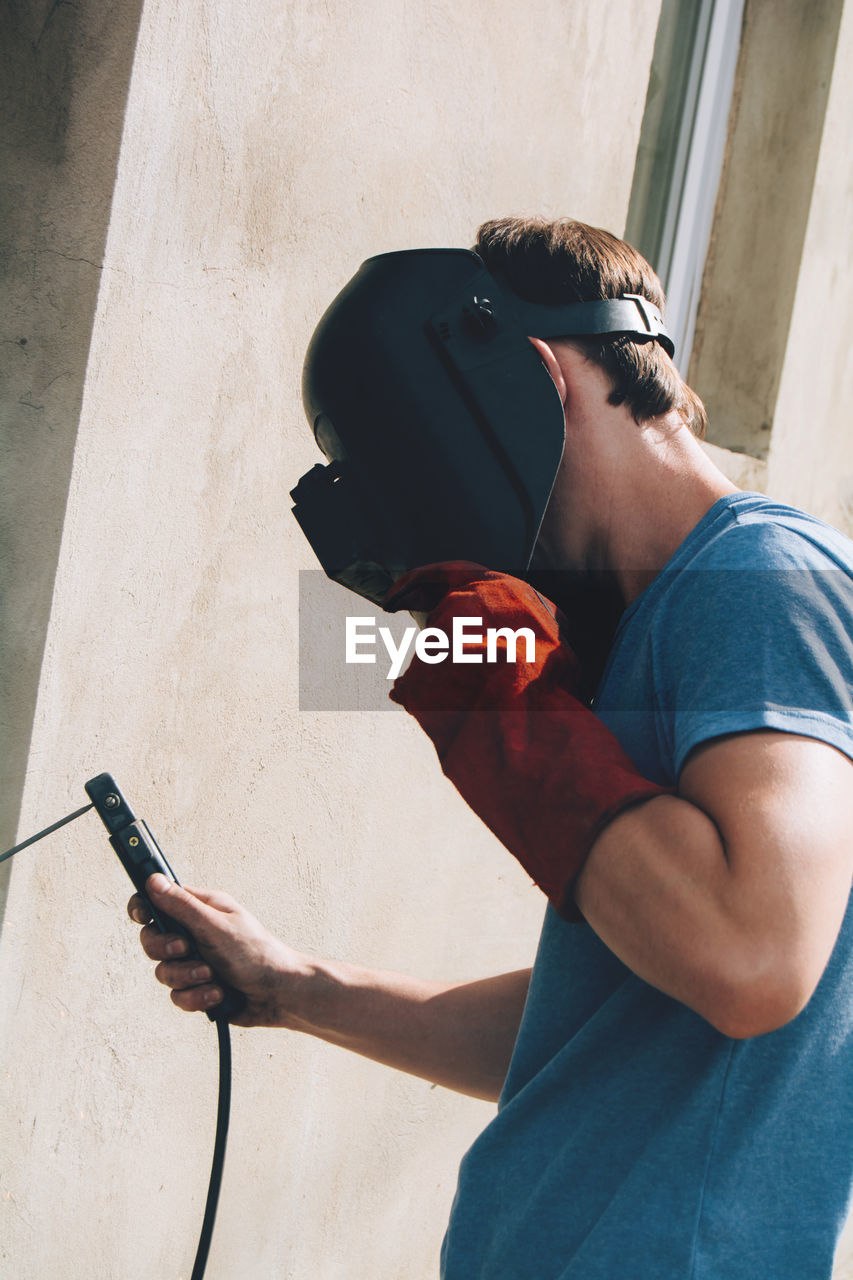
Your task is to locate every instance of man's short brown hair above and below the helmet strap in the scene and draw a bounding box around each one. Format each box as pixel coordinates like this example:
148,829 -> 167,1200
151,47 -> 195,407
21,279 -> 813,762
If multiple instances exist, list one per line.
474,218 -> 707,439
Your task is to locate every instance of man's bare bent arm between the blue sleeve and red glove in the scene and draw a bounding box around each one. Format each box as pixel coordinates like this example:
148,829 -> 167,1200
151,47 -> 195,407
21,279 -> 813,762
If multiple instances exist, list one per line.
575,731 -> 853,1037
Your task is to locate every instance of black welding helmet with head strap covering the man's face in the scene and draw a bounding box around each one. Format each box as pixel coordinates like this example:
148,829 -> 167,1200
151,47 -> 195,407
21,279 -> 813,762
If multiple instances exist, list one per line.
291,248 -> 672,604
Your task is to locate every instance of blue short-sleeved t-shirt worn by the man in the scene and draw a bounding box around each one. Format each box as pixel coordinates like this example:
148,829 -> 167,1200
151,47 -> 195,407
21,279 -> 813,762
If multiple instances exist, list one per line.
442,493 -> 853,1280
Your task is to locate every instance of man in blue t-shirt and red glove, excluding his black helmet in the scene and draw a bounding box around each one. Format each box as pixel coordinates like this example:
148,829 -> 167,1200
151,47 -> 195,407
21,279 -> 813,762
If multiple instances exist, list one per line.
131,220 -> 853,1280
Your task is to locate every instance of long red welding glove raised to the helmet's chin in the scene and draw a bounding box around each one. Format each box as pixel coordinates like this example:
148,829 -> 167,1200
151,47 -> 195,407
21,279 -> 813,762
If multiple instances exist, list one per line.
384,561 -> 669,920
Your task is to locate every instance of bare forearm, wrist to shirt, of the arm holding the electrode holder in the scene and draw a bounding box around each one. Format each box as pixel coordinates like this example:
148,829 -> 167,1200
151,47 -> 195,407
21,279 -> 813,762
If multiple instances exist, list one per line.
281,960 -> 530,1102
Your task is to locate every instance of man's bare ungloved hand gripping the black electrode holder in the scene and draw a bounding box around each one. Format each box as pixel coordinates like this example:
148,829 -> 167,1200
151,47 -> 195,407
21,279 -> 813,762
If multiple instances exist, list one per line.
128,876 -> 310,1027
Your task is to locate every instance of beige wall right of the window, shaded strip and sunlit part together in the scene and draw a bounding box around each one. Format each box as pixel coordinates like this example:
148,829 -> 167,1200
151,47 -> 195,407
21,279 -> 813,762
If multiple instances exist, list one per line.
690,0 -> 853,547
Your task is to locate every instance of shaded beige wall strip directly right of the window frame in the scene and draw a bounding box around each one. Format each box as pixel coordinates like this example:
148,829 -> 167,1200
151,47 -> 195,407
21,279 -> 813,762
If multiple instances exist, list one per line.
689,0 -> 849,458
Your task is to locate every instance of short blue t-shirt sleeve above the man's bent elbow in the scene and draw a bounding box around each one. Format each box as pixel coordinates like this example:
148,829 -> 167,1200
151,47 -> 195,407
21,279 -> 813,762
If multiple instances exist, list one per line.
652,526 -> 853,777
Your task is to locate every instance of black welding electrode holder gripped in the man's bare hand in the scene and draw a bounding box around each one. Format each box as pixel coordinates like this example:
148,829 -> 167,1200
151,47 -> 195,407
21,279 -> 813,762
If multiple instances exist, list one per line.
86,773 -> 246,1023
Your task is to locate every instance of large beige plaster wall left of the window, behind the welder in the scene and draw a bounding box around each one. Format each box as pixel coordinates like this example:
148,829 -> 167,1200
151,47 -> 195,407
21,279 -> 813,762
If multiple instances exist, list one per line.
0,0 -> 658,1280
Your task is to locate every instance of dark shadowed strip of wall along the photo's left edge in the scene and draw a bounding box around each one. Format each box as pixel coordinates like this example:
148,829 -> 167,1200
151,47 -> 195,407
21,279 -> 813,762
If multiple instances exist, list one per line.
0,0 -> 142,920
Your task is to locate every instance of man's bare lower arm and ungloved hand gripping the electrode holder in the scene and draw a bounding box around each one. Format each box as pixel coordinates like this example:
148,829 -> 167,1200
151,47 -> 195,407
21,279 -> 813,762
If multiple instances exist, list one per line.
128,876 -> 530,1102
